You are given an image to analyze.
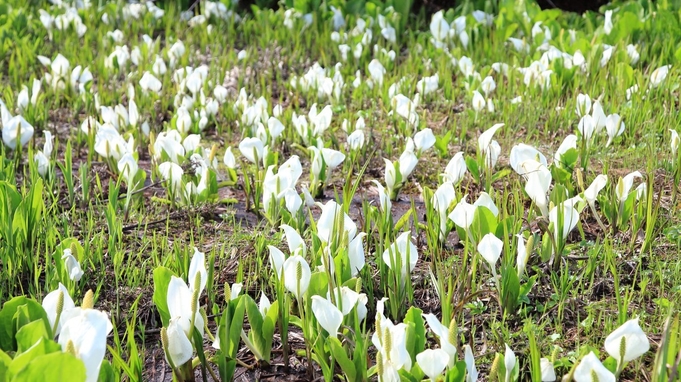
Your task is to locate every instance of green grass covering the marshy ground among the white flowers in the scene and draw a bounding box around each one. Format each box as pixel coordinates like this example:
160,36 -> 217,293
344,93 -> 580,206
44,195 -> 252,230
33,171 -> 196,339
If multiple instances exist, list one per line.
0,1 -> 681,381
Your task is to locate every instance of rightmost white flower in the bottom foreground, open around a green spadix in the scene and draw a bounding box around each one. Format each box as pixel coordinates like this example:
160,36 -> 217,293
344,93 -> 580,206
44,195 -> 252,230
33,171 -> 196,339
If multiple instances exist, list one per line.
605,318 -> 650,368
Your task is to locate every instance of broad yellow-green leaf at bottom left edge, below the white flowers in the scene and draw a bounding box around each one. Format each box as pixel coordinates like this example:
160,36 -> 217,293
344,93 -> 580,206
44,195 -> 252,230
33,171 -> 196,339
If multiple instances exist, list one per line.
12,345 -> 85,382
